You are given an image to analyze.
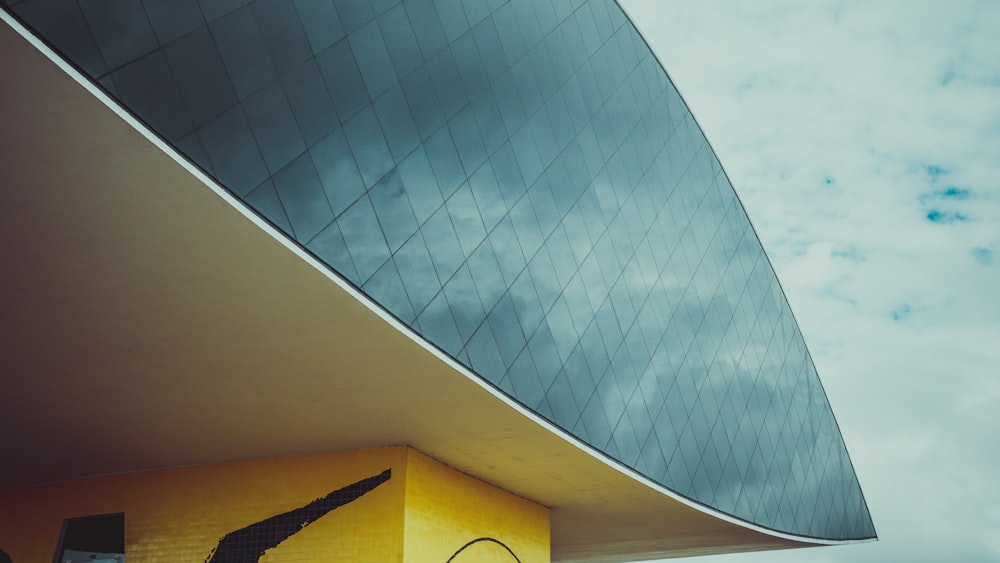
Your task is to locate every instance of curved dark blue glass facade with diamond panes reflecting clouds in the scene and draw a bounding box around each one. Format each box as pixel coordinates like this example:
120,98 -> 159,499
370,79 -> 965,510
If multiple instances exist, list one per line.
0,0 -> 874,540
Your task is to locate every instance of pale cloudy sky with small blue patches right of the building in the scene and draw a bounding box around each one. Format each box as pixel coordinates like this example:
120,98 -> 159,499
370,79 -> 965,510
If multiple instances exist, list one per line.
621,0 -> 1000,563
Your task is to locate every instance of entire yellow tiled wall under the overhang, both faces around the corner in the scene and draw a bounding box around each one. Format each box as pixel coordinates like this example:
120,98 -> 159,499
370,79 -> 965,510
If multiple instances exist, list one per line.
0,446 -> 549,563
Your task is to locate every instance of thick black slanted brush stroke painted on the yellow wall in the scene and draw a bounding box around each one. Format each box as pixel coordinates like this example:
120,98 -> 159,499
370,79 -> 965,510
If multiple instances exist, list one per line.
204,469 -> 392,563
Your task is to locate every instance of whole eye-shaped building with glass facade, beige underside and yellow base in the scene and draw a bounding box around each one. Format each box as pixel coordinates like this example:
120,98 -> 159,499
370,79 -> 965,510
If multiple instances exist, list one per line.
0,0 -> 874,563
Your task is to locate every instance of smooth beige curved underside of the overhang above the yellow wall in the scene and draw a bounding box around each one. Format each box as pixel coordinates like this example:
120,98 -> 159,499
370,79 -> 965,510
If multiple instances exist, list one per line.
0,14 -> 836,561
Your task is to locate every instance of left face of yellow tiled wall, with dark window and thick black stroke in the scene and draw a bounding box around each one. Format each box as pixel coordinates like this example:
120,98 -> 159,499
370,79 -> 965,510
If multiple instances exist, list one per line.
0,447 -> 406,563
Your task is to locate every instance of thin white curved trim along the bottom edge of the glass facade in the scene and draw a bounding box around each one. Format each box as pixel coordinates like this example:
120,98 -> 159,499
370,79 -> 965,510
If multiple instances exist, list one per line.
0,6 -> 870,556
